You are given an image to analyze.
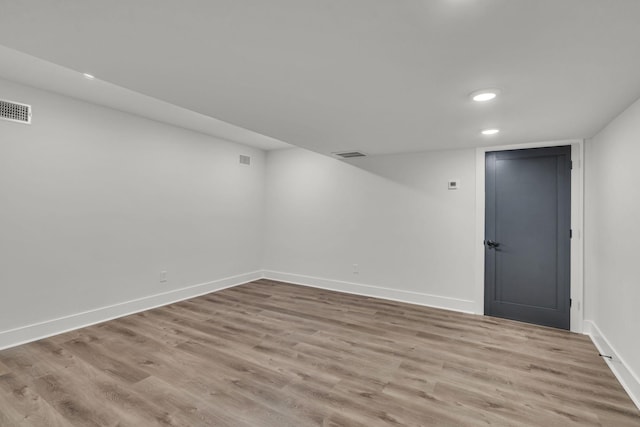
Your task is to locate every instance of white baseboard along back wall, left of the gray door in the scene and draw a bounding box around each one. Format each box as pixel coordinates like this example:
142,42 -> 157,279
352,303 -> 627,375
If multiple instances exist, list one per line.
263,270 -> 475,314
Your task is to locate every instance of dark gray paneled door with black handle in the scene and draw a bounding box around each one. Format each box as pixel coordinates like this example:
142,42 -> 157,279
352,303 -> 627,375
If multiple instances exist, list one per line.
485,147 -> 571,329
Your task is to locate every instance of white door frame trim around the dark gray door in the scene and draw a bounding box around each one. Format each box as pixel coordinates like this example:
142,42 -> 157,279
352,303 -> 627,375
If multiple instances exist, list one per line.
474,139 -> 584,333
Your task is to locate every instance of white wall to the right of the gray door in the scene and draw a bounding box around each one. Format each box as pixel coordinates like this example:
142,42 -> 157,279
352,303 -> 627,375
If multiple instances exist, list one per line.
585,95 -> 640,405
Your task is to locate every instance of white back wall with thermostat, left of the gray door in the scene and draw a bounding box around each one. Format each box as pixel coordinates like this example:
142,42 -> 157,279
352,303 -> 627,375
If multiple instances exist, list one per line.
264,148 -> 475,311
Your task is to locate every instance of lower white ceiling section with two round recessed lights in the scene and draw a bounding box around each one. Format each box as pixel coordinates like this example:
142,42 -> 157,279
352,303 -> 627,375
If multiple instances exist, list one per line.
0,0 -> 640,154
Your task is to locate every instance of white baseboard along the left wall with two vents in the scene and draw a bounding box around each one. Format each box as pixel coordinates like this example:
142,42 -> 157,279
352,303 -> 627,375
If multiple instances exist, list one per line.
0,271 -> 262,350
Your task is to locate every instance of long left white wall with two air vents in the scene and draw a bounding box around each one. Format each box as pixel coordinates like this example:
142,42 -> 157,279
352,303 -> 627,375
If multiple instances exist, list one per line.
0,80 -> 264,347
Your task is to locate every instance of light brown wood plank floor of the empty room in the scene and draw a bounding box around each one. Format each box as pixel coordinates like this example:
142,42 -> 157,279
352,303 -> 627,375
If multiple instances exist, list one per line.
0,280 -> 640,427
